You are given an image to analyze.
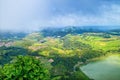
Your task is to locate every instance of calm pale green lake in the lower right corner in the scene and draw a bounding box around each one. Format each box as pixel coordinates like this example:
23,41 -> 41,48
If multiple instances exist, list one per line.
80,54 -> 120,80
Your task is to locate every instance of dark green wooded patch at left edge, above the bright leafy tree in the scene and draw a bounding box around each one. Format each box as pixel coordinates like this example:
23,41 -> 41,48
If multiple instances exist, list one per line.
0,46 -> 28,65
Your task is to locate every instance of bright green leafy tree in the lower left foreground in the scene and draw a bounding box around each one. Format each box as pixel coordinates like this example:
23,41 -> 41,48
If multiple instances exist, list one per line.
0,56 -> 50,80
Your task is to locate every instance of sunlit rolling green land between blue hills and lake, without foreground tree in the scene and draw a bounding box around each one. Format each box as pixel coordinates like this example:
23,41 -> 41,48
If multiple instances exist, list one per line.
0,29 -> 120,80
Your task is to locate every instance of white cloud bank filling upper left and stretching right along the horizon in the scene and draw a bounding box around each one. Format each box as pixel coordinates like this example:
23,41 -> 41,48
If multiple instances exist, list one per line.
0,0 -> 120,31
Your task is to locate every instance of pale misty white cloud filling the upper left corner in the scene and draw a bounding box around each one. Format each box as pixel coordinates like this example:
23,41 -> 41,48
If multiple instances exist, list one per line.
0,0 -> 49,31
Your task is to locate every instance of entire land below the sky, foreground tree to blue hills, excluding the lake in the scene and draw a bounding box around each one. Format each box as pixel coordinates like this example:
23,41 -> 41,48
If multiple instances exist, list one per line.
0,27 -> 120,80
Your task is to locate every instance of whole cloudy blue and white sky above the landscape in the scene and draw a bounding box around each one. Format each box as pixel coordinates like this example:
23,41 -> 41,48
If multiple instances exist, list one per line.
0,0 -> 120,31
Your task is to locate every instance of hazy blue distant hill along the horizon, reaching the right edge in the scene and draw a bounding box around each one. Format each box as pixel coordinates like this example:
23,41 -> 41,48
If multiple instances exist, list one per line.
42,26 -> 120,36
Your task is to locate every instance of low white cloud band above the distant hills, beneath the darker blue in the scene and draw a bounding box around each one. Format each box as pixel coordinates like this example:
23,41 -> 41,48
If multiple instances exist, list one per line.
49,5 -> 120,26
